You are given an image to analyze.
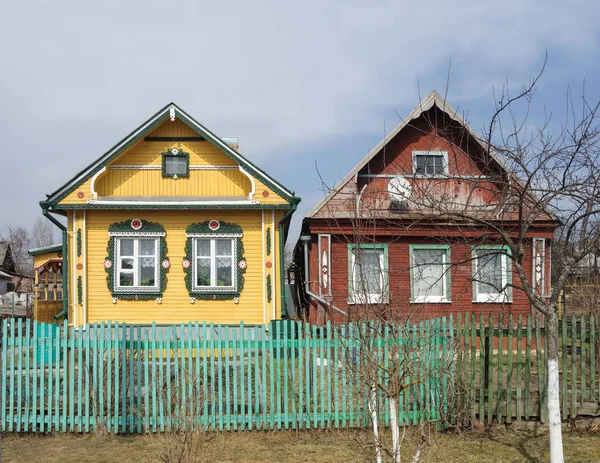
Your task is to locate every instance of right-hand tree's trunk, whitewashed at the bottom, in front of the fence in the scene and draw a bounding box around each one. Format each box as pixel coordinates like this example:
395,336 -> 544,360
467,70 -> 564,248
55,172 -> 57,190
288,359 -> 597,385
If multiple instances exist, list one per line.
546,312 -> 565,463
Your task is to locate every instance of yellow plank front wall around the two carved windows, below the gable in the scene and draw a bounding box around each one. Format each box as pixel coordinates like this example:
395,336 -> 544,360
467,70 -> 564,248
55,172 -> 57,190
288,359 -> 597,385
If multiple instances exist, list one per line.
81,210 -> 280,324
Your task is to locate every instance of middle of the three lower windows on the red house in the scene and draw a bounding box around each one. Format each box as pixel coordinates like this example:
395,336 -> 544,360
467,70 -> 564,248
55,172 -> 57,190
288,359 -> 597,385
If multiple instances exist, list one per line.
410,245 -> 451,303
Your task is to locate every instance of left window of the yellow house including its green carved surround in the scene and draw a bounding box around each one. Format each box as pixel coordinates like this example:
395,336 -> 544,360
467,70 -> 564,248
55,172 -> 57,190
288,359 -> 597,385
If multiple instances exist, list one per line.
104,218 -> 170,300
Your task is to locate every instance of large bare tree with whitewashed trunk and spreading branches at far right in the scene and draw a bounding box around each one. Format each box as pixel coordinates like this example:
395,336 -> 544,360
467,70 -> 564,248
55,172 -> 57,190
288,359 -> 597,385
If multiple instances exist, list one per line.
410,73 -> 600,463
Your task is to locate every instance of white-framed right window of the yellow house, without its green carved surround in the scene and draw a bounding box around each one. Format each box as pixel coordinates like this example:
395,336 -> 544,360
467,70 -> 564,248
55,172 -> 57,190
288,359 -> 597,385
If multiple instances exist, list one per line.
194,238 -> 236,289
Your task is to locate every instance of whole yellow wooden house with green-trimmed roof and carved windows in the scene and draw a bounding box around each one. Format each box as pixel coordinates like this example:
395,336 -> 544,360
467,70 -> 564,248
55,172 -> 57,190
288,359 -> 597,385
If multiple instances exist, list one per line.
37,103 -> 300,327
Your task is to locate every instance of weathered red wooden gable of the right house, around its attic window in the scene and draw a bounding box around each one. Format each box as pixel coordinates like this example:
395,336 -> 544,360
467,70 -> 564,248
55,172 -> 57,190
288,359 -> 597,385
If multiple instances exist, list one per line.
309,106 -> 504,218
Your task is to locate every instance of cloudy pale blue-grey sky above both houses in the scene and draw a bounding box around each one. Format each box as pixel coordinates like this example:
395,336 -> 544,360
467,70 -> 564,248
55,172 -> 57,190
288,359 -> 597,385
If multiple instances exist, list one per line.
0,0 -> 600,245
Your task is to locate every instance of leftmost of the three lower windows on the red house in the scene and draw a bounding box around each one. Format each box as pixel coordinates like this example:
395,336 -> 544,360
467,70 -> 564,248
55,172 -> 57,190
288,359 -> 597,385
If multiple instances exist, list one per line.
348,244 -> 388,304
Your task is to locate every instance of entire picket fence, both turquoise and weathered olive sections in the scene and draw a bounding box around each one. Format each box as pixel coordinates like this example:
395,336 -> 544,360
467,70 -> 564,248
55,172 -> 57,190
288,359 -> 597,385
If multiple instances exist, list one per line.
0,314 -> 600,433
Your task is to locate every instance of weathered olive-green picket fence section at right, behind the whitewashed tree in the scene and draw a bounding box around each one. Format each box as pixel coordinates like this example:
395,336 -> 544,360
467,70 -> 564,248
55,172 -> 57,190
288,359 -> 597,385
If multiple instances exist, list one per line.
455,314 -> 600,424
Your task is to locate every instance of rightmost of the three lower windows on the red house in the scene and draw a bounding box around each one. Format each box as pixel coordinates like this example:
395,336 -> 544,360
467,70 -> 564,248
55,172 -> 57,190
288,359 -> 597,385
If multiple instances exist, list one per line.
473,246 -> 512,302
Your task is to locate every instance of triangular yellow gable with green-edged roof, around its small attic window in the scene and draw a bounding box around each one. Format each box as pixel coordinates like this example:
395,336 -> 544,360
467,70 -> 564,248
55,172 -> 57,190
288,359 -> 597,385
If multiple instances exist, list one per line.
47,104 -> 299,209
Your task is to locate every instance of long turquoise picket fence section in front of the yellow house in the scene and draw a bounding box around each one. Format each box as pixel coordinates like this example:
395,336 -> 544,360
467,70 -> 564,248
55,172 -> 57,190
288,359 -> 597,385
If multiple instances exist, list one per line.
0,318 -> 455,433
